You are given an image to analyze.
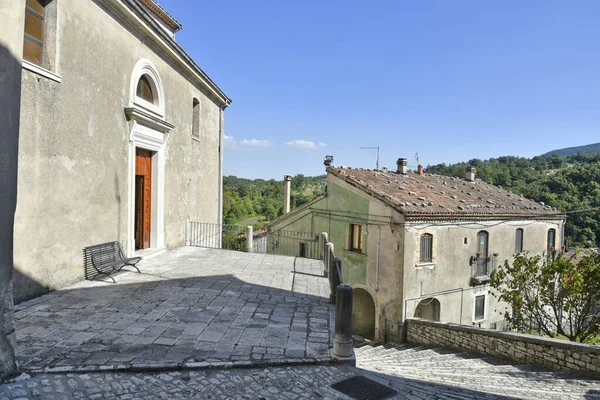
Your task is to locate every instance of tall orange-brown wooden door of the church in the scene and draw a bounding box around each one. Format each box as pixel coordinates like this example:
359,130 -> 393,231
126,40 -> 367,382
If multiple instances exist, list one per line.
135,149 -> 152,250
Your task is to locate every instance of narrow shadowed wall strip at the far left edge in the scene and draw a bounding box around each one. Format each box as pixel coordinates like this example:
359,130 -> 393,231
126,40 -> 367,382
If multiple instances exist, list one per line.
0,0 -> 25,382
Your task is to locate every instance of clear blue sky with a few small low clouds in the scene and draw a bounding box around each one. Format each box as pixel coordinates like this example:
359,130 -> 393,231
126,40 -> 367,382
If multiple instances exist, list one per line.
159,0 -> 600,179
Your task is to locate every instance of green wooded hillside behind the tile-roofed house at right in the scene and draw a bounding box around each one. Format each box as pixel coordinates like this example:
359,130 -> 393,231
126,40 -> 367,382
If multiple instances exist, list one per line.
425,153 -> 600,247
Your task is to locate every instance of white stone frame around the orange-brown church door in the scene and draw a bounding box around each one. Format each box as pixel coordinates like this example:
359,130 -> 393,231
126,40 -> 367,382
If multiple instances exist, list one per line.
125,121 -> 167,256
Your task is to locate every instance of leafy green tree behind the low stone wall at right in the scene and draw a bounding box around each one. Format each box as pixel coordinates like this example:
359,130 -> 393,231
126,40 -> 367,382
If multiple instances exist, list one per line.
490,252 -> 600,342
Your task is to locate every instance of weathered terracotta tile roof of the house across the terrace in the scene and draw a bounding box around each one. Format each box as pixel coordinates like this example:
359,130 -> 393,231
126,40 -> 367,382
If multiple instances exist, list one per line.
327,166 -> 563,218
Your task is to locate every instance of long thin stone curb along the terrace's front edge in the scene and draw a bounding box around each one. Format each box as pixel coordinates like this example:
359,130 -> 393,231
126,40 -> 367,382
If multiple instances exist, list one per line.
21,357 -> 356,375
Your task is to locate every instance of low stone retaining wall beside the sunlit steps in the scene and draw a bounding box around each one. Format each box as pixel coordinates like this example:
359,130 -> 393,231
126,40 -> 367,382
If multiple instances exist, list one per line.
404,318 -> 600,376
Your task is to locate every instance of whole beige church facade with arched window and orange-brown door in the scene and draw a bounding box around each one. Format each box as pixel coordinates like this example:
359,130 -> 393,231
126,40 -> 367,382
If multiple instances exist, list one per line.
9,0 -> 231,302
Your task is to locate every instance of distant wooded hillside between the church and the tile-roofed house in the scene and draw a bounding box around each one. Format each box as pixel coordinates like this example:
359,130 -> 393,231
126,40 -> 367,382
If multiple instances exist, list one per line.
223,174 -> 325,224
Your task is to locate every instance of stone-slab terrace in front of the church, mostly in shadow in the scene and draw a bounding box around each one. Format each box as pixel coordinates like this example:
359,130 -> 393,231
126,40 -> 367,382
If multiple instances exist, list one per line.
15,247 -> 332,372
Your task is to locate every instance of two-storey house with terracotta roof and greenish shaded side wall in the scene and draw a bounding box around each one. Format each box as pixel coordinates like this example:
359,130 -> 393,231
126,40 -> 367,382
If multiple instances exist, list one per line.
269,159 -> 565,340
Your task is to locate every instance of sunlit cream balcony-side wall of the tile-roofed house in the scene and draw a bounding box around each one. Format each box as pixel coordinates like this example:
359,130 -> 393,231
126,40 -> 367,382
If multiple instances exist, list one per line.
404,220 -> 562,327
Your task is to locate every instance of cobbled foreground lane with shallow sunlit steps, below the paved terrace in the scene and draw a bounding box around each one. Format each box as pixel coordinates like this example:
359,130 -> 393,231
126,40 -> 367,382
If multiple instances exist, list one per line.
0,346 -> 600,400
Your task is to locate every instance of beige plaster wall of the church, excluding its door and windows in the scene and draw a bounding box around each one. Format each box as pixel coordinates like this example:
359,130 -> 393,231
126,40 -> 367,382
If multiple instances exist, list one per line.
15,0 -> 225,300
